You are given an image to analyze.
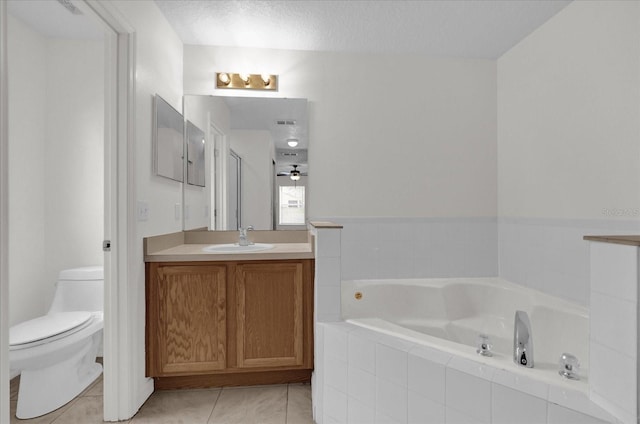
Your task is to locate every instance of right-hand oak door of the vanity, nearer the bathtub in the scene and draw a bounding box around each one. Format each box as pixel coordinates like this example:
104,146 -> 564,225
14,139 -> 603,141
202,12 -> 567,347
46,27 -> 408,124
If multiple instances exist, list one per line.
236,263 -> 303,368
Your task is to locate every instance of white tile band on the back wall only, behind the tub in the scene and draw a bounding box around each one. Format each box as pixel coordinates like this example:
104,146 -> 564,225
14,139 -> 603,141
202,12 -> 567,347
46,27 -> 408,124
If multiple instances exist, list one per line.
330,217 -> 498,280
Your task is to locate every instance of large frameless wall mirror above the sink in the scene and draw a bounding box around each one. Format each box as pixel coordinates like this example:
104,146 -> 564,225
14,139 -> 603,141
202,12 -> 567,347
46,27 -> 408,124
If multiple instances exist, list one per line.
183,95 -> 309,230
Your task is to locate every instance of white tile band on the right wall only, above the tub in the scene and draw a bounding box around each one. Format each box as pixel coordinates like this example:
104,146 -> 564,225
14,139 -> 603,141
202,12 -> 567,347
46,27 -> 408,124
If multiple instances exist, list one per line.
497,217 -> 640,306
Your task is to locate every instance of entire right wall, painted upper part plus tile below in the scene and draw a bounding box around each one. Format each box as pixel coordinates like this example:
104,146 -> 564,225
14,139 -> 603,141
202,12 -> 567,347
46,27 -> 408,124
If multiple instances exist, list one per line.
498,1 -> 640,305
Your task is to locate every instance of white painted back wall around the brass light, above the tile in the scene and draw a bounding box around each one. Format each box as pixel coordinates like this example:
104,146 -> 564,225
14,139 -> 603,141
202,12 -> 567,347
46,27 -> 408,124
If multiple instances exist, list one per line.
184,45 -> 497,218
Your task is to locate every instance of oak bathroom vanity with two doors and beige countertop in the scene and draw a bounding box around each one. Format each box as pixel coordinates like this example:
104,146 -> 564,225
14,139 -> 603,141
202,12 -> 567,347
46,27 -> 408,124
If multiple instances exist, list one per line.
145,231 -> 314,389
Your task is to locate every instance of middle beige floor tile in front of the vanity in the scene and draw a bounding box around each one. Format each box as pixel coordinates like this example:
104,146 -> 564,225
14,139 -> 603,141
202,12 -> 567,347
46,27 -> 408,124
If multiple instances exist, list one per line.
209,385 -> 287,424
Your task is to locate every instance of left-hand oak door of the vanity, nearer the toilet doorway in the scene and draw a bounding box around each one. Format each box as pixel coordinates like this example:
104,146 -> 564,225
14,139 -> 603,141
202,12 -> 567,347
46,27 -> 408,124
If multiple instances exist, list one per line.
156,265 -> 226,375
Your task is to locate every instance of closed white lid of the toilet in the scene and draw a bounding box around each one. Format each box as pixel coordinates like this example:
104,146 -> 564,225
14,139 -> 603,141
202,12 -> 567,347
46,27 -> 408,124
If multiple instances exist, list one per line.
9,311 -> 91,346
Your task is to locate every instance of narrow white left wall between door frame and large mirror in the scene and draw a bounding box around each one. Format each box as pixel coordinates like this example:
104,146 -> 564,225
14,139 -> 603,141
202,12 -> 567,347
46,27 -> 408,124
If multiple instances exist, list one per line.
111,1 -> 183,415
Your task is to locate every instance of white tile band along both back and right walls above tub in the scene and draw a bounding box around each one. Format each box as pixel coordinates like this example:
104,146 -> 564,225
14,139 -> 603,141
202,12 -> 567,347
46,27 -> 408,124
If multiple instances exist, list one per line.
324,217 -> 640,306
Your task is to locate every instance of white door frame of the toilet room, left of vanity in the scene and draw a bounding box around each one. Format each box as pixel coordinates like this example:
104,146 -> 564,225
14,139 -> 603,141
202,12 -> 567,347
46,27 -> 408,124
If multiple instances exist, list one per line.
84,0 -> 146,421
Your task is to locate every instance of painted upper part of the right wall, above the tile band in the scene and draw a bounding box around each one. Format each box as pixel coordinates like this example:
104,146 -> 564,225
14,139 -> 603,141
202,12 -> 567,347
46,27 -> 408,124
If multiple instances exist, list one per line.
498,1 -> 640,219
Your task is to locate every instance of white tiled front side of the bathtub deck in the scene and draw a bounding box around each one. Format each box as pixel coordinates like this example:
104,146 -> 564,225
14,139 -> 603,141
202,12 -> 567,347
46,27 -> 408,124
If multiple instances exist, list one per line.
316,323 -> 617,424
